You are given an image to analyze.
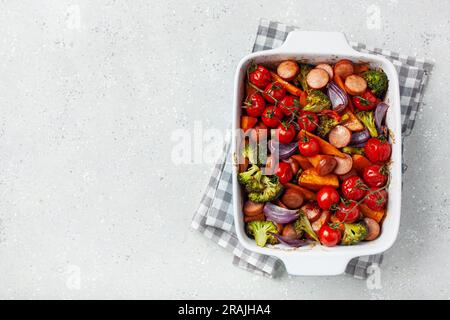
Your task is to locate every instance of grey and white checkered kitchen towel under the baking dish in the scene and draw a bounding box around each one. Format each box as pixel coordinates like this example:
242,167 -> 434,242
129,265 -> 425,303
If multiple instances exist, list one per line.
192,19 -> 433,279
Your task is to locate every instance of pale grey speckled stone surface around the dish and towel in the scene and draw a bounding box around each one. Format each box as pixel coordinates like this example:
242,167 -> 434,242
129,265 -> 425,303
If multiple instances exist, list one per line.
0,0 -> 450,299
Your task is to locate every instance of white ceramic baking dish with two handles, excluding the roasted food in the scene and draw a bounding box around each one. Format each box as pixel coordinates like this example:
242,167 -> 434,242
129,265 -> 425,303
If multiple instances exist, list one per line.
232,31 -> 402,275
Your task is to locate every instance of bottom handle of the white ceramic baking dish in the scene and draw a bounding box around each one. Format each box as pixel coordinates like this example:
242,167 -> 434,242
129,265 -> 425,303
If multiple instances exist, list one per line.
279,254 -> 354,276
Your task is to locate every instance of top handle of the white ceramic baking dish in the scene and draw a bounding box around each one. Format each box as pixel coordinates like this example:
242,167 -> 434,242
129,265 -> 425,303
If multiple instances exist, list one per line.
278,31 -> 361,56
